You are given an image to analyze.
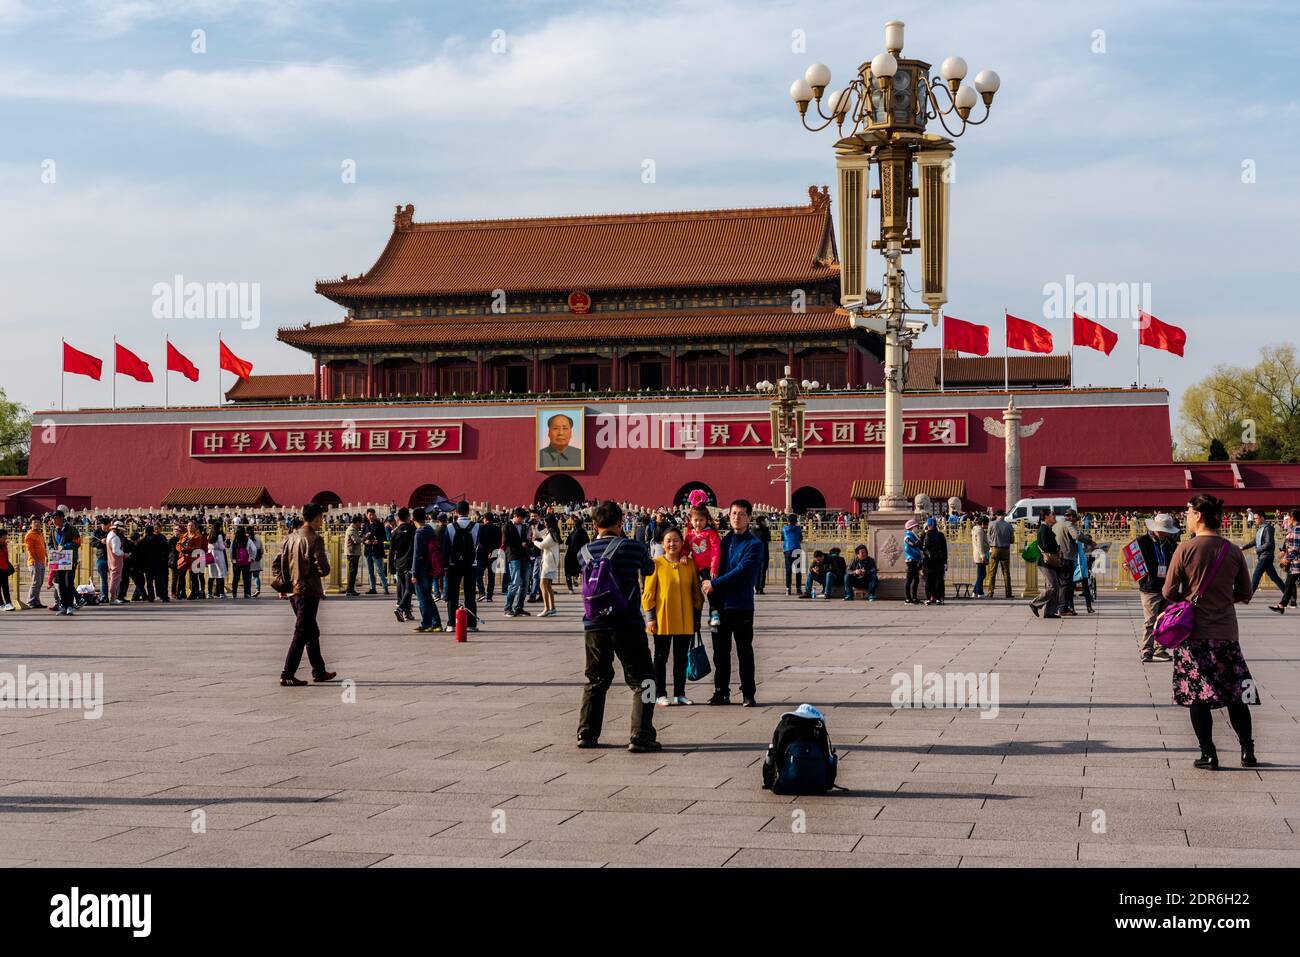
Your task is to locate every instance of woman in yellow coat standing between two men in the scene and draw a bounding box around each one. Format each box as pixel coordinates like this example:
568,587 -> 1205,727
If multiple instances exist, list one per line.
641,528 -> 705,707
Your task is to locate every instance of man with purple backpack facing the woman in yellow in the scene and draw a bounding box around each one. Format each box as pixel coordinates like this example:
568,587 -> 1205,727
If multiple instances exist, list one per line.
577,502 -> 663,754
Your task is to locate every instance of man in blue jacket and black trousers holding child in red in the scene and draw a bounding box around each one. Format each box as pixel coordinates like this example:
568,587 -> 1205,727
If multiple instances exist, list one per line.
701,498 -> 764,707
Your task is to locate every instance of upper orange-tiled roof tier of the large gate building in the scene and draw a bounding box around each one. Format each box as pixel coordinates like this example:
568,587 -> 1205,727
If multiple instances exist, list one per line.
316,187 -> 840,304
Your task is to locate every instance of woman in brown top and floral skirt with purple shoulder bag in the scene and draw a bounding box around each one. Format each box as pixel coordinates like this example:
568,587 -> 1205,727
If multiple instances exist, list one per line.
1165,495 -> 1258,771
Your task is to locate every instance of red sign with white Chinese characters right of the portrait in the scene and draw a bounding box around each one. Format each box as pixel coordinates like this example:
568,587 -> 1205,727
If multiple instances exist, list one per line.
662,412 -> 970,451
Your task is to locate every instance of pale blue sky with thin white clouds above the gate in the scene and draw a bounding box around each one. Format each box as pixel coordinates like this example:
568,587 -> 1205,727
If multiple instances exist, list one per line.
0,0 -> 1300,442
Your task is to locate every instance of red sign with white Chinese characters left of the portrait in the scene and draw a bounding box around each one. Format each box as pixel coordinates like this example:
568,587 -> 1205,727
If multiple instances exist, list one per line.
190,423 -> 464,459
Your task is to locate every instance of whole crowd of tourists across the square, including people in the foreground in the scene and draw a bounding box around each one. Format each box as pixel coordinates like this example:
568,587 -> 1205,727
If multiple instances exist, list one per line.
0,493 -> 1279,768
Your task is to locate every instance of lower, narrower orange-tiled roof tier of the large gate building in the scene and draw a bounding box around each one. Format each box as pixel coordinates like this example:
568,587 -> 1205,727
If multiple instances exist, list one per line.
277,306 -> 850,353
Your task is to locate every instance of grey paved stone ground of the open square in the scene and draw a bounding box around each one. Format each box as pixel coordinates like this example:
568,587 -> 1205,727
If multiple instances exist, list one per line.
0,593 -> 1300,867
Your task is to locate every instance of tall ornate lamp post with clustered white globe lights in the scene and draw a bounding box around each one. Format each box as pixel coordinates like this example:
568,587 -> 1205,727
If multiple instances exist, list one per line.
790,20 -> 1001,597
